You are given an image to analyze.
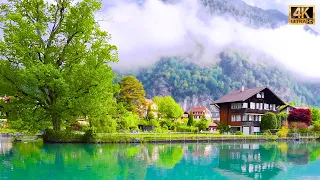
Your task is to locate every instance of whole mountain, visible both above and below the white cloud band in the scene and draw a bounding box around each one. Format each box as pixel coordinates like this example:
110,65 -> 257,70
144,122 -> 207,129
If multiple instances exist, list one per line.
118,0 -> 320,109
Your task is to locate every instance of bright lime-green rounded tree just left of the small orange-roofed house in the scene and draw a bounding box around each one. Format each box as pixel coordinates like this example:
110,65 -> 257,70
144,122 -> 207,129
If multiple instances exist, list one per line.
153,96 -> 183,119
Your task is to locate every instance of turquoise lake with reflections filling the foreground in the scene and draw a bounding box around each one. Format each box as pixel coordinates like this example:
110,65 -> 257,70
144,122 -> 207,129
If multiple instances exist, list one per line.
0,142 -> 320,180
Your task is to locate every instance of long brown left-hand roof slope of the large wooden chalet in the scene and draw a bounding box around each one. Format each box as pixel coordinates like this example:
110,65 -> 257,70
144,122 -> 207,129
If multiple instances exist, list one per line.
213,86 -> 267,104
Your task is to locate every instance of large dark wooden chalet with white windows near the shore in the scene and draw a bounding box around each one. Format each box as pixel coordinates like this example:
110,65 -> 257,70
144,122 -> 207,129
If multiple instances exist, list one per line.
213,86 -> 285,134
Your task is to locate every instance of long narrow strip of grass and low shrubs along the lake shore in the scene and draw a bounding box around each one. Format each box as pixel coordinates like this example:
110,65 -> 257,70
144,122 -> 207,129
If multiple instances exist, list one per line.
43,132 -> 318,143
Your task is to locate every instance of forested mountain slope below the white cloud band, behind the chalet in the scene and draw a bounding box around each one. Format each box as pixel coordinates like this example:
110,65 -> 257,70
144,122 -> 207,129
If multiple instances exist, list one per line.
136,53 -> 320,109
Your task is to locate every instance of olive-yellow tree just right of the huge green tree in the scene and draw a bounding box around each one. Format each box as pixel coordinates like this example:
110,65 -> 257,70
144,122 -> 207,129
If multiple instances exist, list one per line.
117,76 -> 147,117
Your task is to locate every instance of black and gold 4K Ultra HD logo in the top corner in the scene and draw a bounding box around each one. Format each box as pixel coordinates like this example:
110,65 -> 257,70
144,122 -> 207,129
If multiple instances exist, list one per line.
289,5 -> 316,24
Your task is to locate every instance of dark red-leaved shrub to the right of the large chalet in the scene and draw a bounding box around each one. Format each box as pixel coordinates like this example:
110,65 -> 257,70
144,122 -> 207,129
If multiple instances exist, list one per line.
288,109 -> 311,126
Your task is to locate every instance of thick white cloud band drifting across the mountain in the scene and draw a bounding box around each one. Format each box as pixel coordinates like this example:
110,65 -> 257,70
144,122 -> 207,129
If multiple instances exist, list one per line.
97,0 -> 320,78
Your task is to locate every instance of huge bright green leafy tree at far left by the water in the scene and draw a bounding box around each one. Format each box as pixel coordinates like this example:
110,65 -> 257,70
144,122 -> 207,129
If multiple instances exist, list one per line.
0,0 -> 117,131
